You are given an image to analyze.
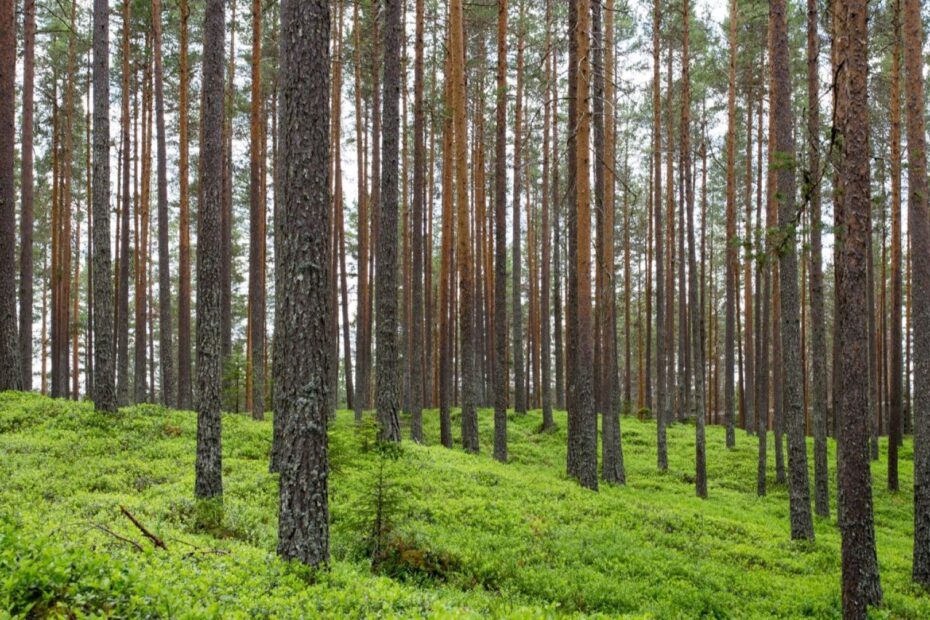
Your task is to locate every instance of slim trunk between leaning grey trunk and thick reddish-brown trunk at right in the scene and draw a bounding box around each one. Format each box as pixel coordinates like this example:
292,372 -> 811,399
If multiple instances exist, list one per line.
804,0 -> 828,517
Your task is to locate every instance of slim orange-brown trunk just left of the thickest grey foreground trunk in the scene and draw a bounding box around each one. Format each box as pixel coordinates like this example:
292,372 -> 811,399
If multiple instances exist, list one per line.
248,0 -> 262,420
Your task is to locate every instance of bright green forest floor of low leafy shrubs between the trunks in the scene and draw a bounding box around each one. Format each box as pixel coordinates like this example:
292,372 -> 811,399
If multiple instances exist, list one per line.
0,393 -> 930,618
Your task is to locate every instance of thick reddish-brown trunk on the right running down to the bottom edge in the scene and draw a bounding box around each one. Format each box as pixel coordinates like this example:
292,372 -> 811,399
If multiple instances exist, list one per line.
832,0 -> 884,618
